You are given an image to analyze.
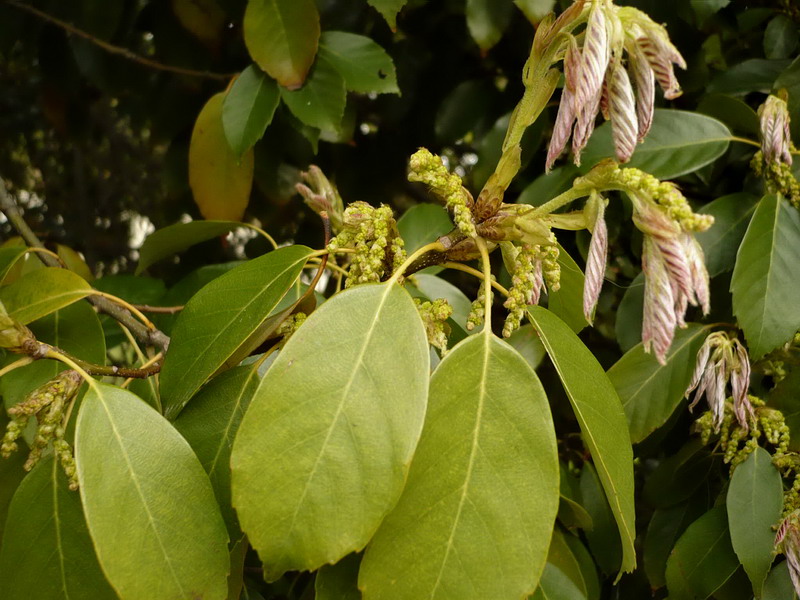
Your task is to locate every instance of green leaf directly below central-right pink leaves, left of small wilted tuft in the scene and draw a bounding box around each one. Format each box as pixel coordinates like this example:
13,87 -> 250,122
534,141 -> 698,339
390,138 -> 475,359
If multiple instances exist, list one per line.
608,324 -> 707,444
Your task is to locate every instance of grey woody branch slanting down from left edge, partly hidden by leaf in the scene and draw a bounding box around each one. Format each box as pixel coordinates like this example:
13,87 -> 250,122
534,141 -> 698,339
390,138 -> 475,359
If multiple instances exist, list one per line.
0,178 -> 169,350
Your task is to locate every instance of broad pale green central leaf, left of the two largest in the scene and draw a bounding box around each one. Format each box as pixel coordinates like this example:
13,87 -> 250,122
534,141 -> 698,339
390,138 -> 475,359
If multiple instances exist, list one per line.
231,283 -> 429,580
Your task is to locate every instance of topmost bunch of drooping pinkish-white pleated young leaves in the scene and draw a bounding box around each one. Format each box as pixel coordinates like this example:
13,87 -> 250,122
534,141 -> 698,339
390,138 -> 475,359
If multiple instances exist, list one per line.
546,0 -> 686,171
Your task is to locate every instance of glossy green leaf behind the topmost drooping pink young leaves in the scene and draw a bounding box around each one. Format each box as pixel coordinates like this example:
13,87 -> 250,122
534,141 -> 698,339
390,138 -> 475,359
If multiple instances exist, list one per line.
583,109 -> 731,179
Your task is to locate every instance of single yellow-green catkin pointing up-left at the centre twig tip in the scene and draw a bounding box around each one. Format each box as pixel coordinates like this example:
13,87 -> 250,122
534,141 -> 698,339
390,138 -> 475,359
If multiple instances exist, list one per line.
408,148 -> 477,237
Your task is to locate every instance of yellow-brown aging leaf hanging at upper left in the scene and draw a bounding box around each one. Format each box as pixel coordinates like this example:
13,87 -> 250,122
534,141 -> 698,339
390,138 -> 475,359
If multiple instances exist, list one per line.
189,93 -> 254,221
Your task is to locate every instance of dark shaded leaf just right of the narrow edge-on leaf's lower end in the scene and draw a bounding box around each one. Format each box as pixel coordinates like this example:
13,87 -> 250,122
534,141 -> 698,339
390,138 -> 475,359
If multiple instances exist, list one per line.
581,463 -> 622,575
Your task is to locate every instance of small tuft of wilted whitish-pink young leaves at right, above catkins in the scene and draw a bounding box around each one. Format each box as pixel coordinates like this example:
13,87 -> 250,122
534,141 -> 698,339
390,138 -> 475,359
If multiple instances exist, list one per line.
684,331 -> 754,431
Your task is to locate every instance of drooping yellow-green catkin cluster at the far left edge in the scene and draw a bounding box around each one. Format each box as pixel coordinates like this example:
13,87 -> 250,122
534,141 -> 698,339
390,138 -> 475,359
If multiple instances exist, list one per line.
0,370 -> 83,490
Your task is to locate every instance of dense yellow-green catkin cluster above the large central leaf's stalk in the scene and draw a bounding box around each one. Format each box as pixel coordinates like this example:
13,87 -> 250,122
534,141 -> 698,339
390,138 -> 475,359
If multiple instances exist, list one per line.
328,202 -> 406,287
